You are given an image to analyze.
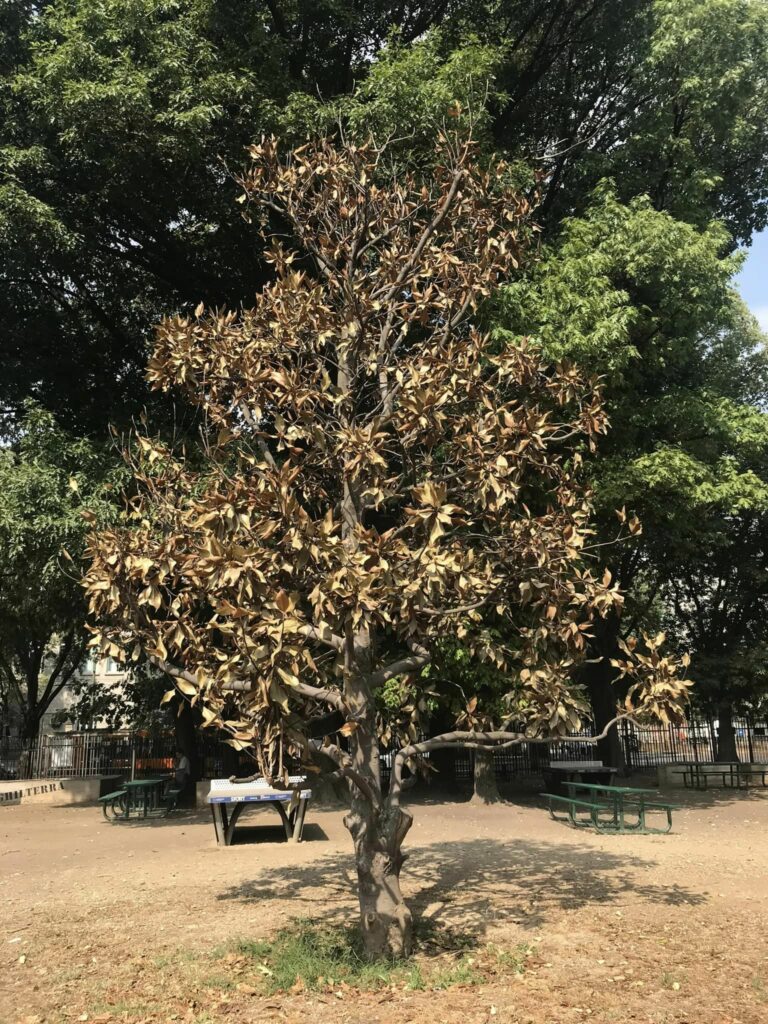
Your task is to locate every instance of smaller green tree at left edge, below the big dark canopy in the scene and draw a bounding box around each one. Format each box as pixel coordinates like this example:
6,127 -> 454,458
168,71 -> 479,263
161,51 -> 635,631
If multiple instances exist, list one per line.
0,407 -> 118,739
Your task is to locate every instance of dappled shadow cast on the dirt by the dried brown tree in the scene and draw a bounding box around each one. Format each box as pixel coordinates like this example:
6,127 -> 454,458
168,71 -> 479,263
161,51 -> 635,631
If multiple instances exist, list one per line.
217,839 -> 707,938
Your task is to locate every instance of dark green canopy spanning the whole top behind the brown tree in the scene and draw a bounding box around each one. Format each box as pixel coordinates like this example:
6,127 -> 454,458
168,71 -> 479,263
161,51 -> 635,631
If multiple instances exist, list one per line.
0,0 -> 768,430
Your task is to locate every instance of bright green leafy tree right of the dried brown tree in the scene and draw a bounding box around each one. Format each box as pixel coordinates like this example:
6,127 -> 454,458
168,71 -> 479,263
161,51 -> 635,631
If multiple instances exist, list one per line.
498,186 -> 768,761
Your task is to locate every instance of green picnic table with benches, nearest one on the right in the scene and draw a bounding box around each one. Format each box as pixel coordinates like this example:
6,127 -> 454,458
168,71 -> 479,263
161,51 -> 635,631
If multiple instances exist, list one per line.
545,782 -> 677,835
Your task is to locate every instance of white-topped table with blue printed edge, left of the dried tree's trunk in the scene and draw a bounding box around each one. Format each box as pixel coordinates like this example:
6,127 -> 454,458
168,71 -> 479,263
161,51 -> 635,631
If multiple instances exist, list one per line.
208,775 -> 312,846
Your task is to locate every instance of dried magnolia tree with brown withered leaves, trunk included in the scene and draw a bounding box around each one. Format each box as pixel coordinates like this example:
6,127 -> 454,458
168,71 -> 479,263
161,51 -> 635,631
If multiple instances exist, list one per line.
85,137 -> 686,955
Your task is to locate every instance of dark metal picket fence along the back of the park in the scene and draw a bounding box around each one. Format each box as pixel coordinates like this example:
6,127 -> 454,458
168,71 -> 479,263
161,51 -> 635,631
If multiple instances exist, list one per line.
0,719 -> 768,779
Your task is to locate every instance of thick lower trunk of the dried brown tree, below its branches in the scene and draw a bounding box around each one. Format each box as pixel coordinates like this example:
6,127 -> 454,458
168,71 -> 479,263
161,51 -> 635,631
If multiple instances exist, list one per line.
344,798 -> 414,959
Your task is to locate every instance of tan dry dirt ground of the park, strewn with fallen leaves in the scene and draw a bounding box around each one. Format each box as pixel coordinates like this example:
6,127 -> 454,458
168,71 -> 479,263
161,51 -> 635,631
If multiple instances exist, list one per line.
0,780 -> 768,1024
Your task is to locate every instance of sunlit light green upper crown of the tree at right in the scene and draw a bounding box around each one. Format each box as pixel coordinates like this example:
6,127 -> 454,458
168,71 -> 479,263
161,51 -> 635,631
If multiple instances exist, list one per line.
502,182 -> 738,372
